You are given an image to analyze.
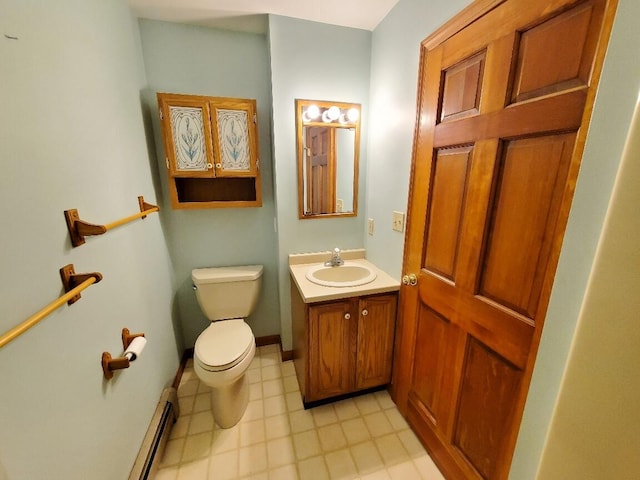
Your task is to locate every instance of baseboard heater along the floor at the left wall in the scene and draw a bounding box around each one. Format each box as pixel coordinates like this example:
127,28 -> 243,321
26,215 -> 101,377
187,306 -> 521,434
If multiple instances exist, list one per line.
129,388 -> 180,480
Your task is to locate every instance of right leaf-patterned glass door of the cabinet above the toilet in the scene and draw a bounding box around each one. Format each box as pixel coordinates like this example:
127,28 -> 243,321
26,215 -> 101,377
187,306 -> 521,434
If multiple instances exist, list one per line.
209,100 -> 258,177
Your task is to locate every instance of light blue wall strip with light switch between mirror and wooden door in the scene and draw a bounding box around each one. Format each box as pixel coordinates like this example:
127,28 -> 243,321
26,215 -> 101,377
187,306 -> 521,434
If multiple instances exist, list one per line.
365,0 -> 469,279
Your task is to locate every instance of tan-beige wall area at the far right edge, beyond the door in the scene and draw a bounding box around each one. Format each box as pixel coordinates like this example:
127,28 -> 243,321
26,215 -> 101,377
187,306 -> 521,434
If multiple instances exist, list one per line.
538,94 -> 640,480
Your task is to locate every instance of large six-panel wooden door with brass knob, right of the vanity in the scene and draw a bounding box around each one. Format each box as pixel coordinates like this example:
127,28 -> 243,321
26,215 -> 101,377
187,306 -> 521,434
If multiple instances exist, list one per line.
392,0 -> 615,480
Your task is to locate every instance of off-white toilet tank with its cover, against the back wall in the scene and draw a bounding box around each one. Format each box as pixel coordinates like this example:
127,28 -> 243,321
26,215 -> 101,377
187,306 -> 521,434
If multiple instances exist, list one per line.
191,265 -> 263,320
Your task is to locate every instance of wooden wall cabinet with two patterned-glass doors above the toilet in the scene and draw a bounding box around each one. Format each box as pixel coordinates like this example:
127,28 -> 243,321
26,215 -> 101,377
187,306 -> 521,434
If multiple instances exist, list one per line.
157,93 -> 262,208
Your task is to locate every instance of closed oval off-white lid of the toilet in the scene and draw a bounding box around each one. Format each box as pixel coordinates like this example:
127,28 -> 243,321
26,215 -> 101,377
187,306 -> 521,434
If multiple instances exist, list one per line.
194,318 -> 255,371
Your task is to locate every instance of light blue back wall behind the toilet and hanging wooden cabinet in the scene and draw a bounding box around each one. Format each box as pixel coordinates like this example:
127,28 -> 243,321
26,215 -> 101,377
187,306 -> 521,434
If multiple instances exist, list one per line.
139,20 -> 280,347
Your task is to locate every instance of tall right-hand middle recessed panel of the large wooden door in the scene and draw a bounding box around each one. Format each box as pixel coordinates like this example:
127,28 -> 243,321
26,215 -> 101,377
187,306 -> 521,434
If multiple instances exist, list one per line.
478,134 -> 575,318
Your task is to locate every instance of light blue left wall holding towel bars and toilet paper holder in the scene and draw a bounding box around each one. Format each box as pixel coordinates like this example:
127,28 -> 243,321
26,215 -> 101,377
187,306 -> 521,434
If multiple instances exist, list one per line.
0,0 -> 179,480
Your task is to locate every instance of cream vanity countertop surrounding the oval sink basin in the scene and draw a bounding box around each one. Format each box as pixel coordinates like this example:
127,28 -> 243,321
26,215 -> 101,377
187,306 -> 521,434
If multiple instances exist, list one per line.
289,249 -> 400,303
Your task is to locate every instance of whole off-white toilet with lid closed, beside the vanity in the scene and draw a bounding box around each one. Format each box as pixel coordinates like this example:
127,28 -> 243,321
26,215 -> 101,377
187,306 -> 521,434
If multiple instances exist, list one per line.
191,265 -> 263,428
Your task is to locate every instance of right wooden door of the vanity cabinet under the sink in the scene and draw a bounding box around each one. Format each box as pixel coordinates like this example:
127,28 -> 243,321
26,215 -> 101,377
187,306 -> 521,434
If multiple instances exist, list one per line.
356,294 -> 397,390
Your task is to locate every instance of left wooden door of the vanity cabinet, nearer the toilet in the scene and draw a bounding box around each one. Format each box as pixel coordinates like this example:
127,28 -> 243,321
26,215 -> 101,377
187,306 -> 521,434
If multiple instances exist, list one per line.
305,300 -> 358,402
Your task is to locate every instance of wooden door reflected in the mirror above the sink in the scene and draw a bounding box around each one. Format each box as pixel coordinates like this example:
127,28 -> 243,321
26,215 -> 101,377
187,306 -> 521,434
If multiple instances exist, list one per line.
306,127 -> 336,214
